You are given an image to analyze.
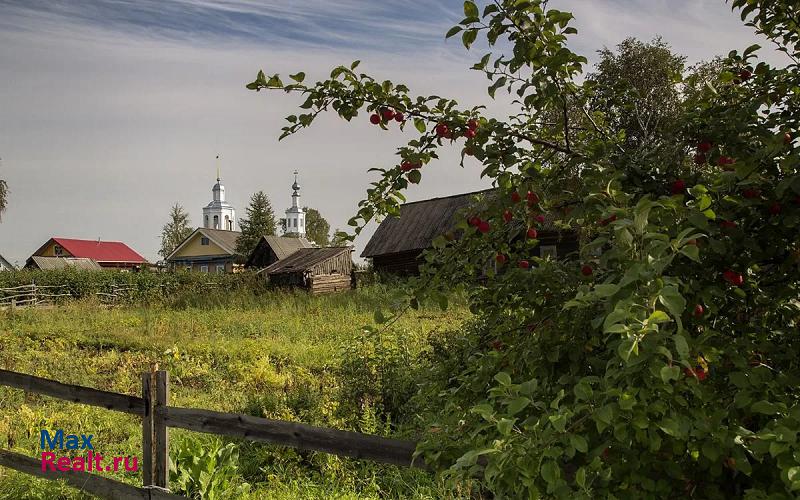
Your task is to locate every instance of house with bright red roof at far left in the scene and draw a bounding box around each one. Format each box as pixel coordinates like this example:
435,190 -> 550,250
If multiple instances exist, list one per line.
25,238 -> 148,269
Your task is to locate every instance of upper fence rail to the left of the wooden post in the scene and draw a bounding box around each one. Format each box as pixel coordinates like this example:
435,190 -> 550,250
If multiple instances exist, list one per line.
0,370 -> 144,415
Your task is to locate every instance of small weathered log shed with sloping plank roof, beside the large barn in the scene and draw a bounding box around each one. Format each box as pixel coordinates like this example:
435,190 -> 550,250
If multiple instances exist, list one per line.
262,247 -> 353,293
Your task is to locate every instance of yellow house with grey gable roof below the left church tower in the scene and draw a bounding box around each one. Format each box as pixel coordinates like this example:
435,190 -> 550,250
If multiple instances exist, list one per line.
166,227 -> 244,274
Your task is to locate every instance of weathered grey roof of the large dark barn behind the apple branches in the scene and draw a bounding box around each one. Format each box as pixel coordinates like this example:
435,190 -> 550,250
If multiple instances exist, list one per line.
361,189 -> 493,257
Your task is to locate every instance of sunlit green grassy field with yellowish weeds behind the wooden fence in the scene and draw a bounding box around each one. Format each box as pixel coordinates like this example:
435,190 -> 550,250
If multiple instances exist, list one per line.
0,286 -> 469,499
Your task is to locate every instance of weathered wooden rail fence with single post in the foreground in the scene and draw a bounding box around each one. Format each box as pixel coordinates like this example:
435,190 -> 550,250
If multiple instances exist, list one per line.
0,370 -> 426,500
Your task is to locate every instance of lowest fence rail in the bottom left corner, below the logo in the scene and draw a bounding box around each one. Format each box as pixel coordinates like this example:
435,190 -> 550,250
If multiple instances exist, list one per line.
0,450 -> 186,500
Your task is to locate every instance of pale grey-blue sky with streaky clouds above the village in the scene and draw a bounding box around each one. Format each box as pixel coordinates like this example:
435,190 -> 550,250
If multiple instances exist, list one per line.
0,0 -> 780,264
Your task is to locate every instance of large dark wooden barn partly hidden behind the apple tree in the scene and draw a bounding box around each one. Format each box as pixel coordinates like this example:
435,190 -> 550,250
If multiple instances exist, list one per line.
361,189 -> 578,275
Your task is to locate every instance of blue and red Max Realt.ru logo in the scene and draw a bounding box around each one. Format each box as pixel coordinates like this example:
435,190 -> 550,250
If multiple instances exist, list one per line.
39,429 -> 139,472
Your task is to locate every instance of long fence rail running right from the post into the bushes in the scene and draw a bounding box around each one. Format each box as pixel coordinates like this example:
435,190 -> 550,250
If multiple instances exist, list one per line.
162,407 -> 425,468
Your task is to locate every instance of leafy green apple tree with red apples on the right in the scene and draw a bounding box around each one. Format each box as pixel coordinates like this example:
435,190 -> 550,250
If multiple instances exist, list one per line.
248,0 -> 800,498
